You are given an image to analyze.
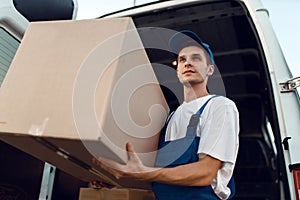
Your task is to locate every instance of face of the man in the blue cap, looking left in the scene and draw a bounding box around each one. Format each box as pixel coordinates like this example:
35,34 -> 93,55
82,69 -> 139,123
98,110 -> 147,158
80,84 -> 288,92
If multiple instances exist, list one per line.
177,46 -> 214,86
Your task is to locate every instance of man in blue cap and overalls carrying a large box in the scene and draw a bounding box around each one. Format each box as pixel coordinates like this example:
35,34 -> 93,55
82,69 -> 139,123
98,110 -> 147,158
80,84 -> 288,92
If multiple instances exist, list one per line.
94,30 -> 239,200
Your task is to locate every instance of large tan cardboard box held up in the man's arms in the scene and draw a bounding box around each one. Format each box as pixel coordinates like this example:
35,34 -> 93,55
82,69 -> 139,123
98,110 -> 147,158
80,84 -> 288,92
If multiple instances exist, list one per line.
0,18 -> 168,188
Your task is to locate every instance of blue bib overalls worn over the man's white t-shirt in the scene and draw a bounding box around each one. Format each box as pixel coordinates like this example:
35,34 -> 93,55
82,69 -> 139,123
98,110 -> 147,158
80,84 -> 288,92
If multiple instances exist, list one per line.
152,96 -> 235,200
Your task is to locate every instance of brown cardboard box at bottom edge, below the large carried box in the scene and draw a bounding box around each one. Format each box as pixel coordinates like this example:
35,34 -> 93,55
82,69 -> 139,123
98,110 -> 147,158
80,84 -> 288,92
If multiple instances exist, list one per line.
79,188 -> 155,200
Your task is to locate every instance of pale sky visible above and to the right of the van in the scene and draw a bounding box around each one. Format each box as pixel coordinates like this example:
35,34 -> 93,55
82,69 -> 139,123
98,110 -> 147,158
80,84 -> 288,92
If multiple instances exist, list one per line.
77,0 -> 300,76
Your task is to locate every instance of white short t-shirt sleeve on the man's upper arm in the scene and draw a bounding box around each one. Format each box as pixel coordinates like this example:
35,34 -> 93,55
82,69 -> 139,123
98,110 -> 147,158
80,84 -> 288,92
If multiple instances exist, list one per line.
198,99 -> 239,164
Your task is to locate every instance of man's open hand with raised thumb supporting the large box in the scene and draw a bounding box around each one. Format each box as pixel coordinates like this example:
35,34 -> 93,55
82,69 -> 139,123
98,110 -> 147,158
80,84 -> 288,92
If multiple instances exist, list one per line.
92,143 -> 154,180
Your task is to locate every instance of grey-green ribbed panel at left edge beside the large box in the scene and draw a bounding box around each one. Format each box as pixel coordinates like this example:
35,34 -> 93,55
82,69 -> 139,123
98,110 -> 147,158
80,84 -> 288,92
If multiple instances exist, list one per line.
0,28 -> 19,87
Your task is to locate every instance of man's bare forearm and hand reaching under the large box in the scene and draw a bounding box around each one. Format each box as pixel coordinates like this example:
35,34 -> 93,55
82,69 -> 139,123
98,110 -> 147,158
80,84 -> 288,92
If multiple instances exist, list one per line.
93,143 -> 222,186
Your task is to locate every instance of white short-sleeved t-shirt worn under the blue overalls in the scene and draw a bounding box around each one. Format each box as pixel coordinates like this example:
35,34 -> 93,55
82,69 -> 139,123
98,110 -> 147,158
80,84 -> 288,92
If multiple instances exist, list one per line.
165,95 -> 239,199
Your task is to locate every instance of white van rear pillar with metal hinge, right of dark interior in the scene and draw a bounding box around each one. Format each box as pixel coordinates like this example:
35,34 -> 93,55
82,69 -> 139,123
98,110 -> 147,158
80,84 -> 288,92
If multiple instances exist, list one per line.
250,1 -> 300,200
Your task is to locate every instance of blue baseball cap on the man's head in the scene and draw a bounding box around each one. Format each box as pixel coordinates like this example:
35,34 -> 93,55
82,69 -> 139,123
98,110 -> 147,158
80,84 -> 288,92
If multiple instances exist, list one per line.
169,30 -> 215,64
